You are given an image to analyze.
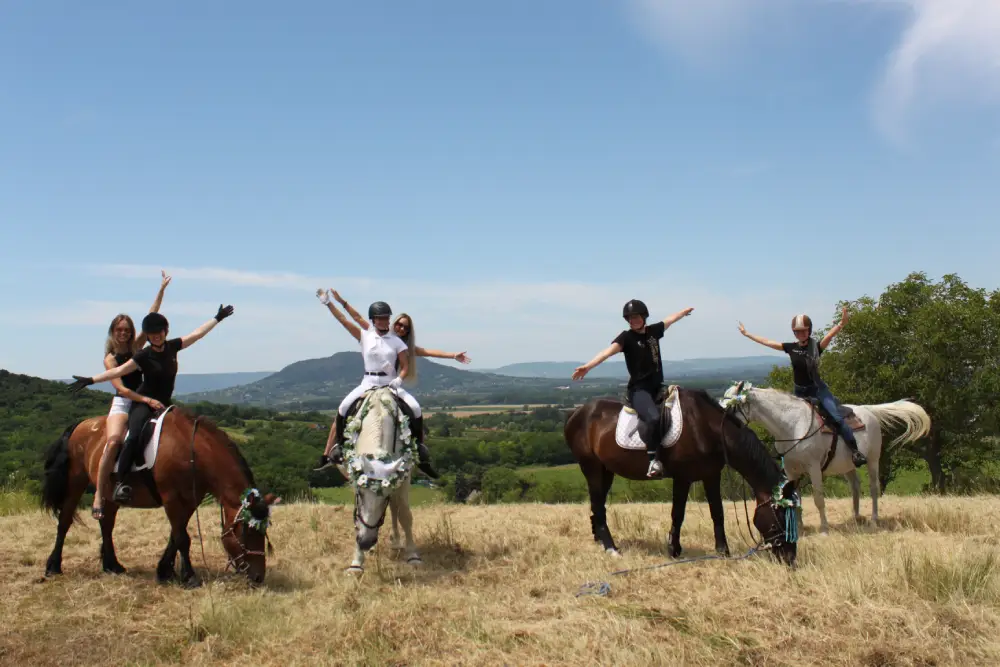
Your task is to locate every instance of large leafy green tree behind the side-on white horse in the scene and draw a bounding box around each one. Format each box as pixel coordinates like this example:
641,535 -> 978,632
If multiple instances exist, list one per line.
770,273 -> 1000,493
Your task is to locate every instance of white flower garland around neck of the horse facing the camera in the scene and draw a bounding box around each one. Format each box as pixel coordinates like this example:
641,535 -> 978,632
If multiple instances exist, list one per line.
343,394 -> 417,496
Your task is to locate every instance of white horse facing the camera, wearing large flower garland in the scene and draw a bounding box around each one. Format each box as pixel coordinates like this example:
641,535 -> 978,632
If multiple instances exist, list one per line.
340,387 -> 422,574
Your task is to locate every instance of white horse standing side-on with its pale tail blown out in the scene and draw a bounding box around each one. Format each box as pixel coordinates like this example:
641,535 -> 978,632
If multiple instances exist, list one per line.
720,382 -> 931,534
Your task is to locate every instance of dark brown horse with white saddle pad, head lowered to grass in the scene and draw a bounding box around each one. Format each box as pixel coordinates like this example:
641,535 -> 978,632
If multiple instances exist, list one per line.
564,389 -> 798,564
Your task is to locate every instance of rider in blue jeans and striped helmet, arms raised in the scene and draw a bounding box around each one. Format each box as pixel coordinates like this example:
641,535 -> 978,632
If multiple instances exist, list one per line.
740,307 -> 868,467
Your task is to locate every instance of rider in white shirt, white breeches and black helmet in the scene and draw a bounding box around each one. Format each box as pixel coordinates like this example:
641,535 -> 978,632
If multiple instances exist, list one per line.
316,289 -> 438,477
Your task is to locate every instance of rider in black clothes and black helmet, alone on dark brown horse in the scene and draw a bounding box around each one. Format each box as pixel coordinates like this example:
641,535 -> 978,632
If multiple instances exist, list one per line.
573,299 -> 694,477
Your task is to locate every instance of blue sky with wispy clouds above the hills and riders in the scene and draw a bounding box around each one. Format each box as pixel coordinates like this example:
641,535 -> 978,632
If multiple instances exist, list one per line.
0,0 -> 1000,377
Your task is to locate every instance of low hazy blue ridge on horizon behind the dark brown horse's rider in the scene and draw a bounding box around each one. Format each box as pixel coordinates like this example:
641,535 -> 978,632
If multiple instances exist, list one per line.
482,355 -> 789,382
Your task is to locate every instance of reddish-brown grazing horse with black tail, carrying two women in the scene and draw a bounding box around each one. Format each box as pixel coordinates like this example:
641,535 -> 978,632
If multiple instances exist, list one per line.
42,407 -> 280,587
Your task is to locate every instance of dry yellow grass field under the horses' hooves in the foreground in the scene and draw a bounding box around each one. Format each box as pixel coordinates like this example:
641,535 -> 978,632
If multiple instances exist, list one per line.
0,496 -> 1000,667
